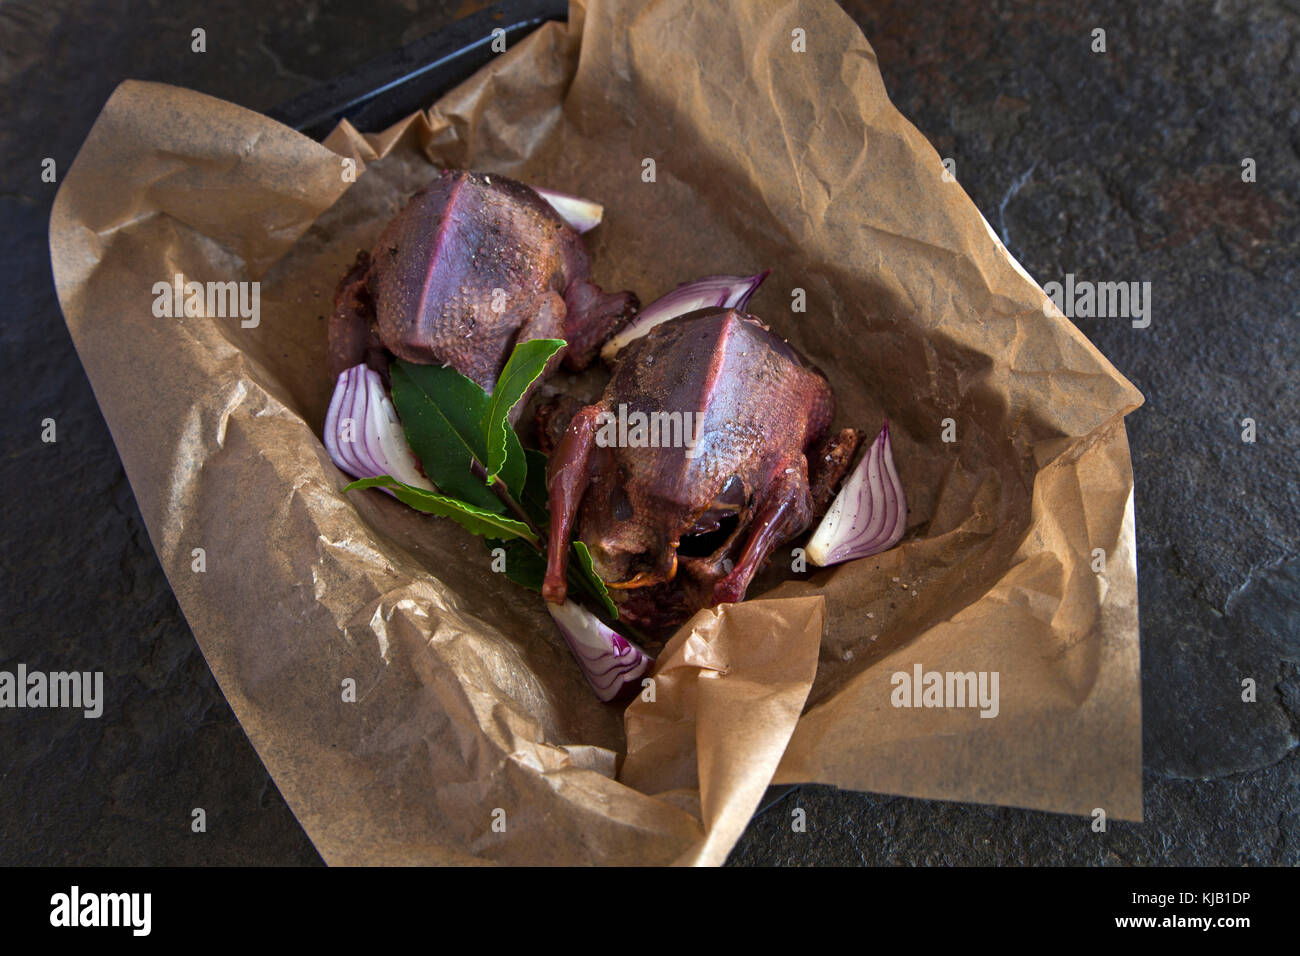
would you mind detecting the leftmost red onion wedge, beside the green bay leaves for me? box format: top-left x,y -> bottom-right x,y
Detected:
324,364 -> 436,494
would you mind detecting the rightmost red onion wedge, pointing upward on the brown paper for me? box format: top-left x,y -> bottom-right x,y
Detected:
803,421 -> 907,567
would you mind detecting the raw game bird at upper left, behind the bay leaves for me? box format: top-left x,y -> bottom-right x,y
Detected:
329,169 -> 637,390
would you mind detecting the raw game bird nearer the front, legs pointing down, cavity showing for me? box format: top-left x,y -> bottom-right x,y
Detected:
543,308 -> 858,632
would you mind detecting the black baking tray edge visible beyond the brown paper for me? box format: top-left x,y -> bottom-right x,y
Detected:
268,0 -> 798,817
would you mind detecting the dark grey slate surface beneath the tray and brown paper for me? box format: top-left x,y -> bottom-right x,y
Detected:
0,0 -> 1300,865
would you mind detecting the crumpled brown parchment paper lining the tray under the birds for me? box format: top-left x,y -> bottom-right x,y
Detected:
51,0 -> 1141,864
